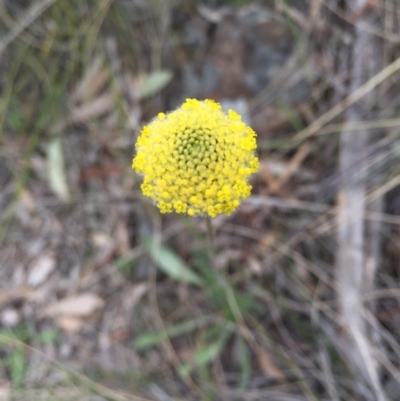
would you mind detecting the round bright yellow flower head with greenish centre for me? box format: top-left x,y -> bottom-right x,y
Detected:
132,99 -> 259,217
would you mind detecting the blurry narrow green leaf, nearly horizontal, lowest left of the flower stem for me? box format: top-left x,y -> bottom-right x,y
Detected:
133,320 -> 201,350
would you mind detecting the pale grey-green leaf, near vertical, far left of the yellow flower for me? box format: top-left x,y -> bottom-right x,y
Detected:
47,137 -> 69,201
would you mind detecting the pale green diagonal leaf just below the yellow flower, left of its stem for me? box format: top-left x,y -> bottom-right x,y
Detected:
144,241 -> 203,287
